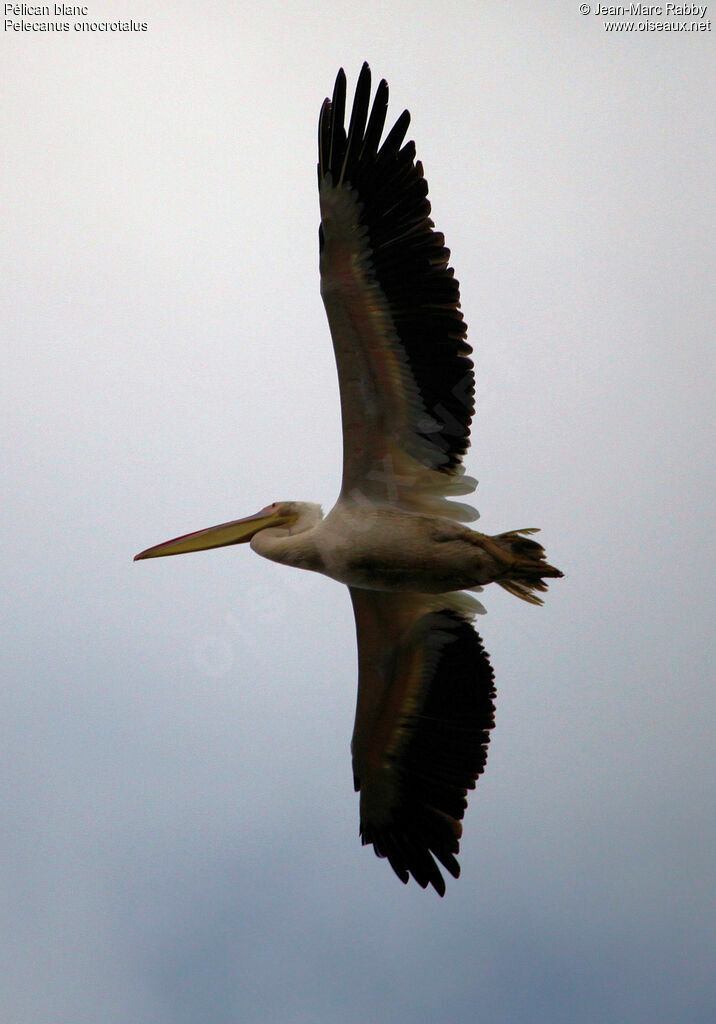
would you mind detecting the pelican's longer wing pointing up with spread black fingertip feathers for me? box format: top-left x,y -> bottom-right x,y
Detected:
319,63 -> 476,519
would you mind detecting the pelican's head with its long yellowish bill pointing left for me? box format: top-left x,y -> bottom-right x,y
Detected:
134,502 -> 323,562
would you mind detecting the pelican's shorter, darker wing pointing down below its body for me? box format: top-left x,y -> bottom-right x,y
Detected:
349,587 -> 495,896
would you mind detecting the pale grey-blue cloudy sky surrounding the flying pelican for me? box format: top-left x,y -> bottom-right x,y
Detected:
0,6 -> 716,1024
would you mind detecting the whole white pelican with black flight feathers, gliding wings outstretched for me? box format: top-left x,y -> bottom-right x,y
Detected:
136,63 -> 562,896
